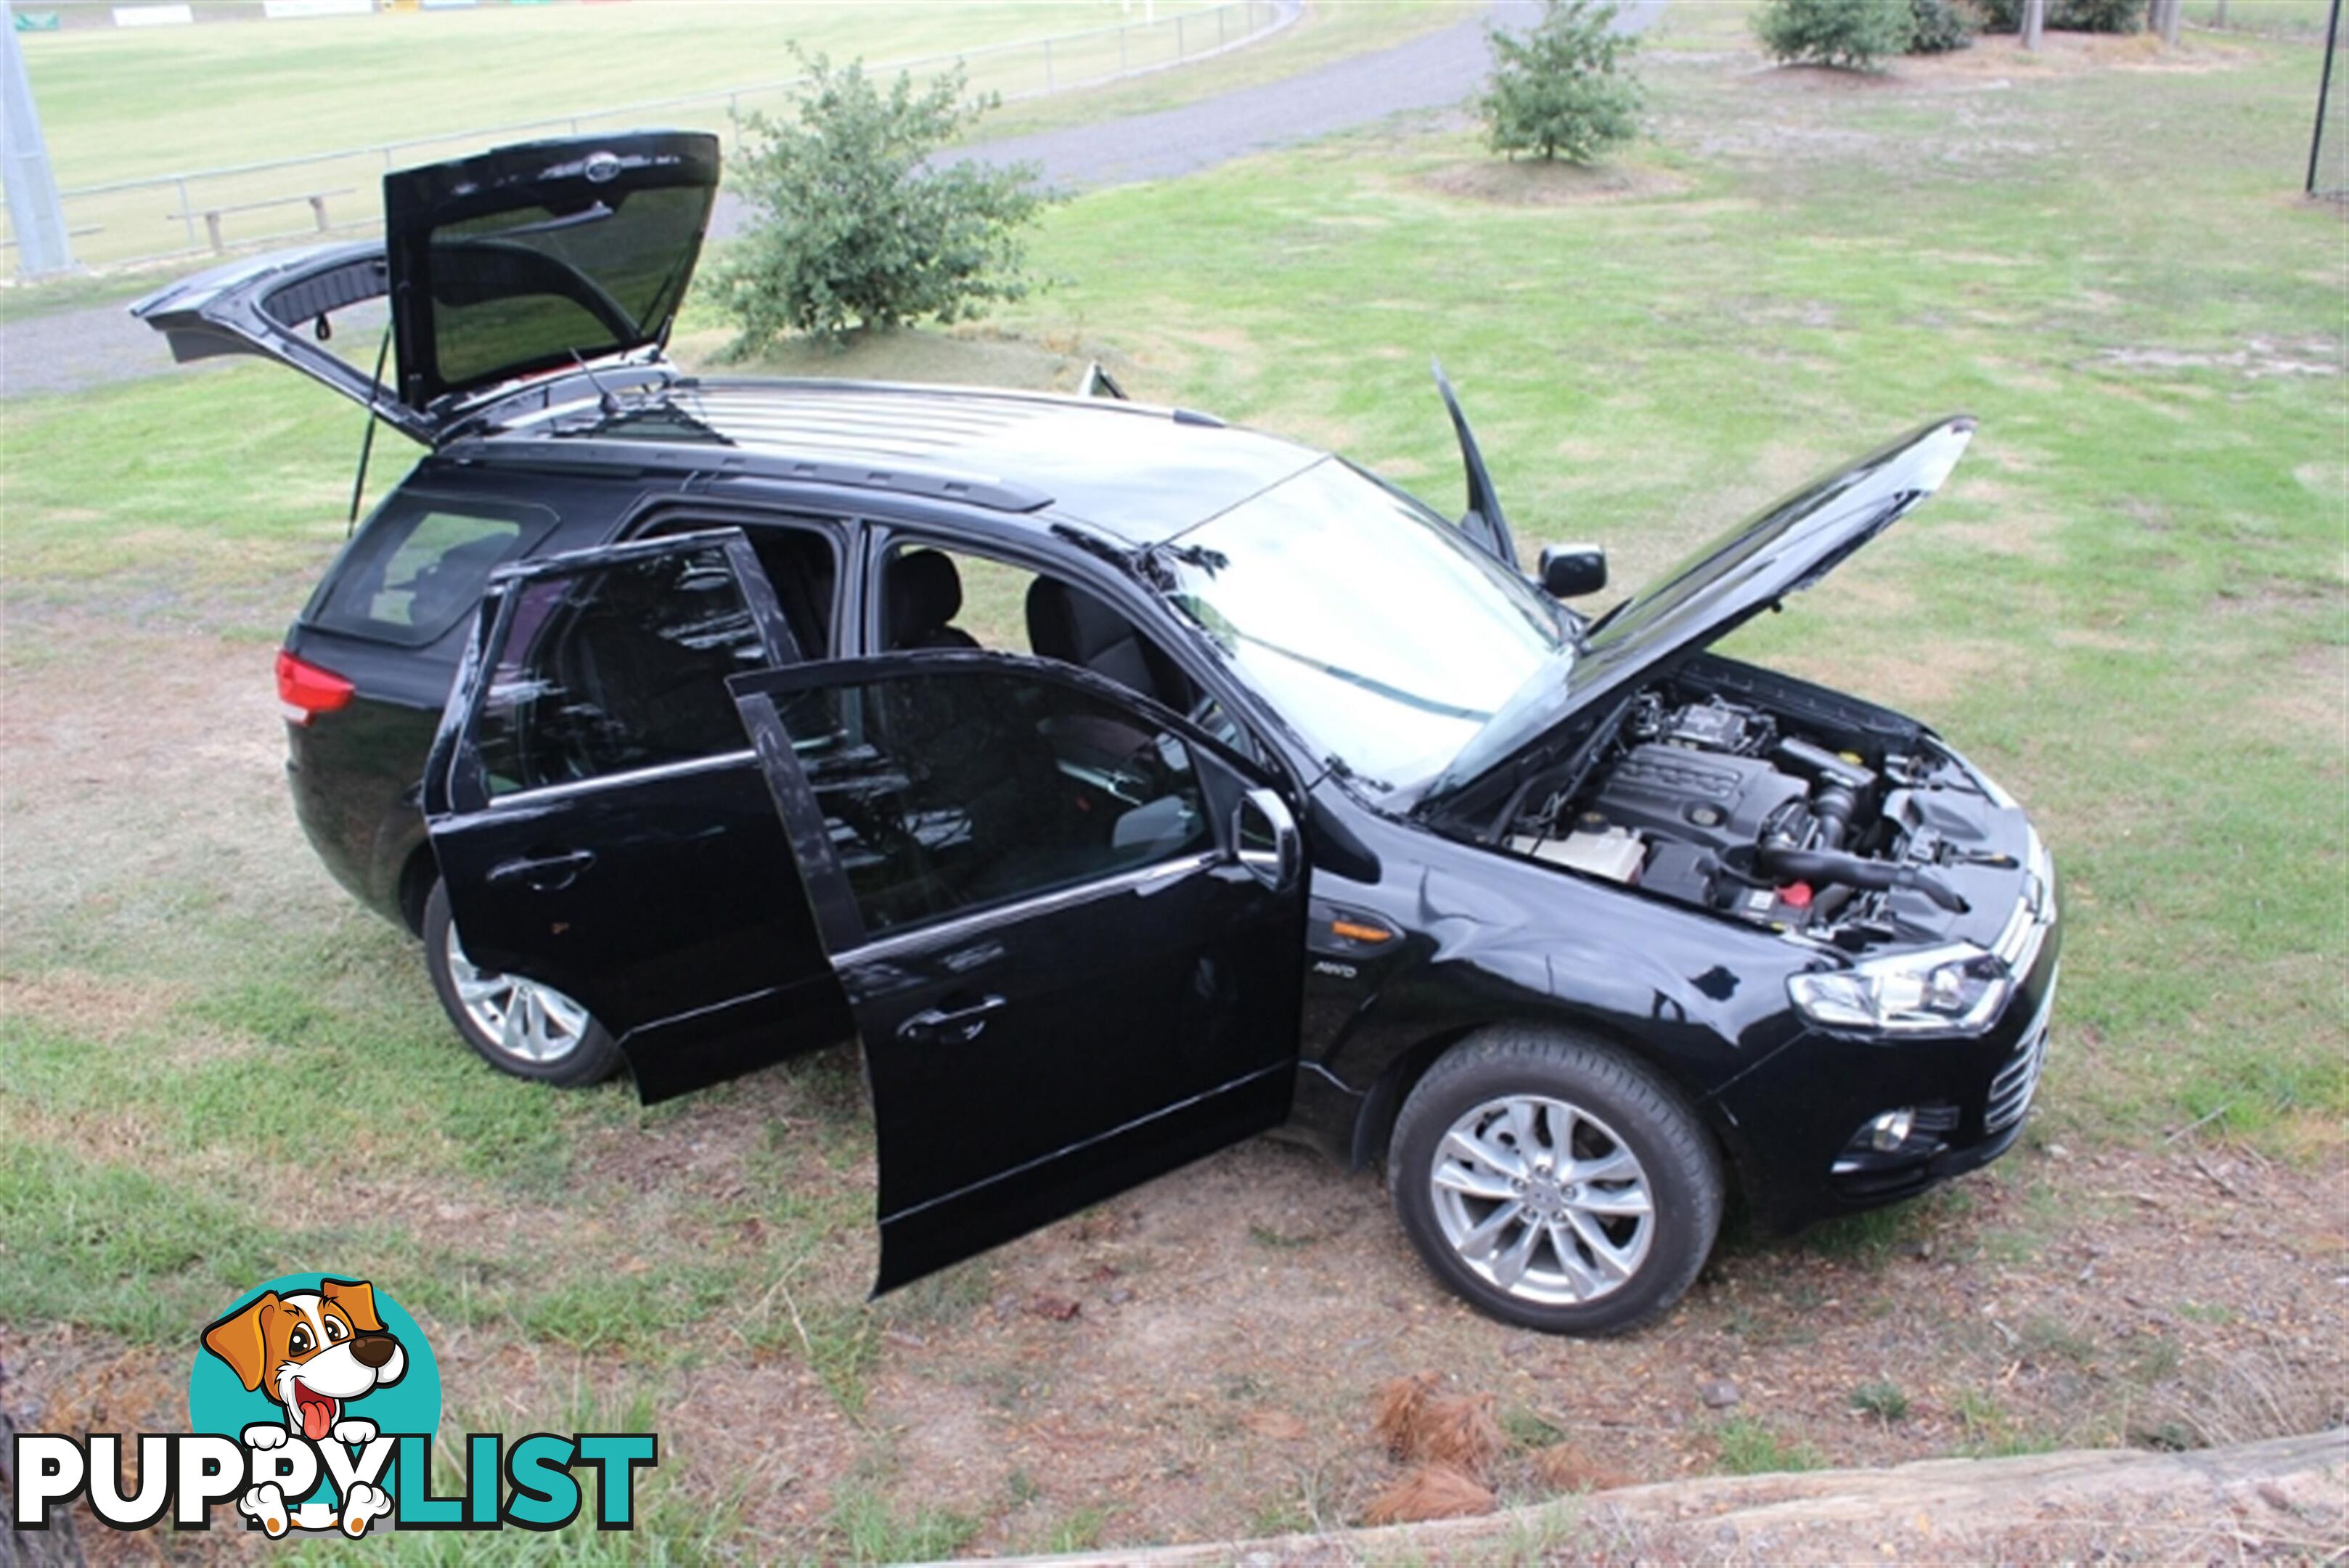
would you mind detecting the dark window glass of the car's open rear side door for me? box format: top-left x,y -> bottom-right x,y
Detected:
475,545 -> 768,795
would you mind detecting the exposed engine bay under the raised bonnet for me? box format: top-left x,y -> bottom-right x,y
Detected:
1503,670 -> 2020,950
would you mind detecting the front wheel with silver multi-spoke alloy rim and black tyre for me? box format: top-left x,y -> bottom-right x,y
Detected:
1386,1027 -> 1722,1335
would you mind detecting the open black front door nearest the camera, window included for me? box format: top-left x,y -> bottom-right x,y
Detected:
733,653 -> 1304,1291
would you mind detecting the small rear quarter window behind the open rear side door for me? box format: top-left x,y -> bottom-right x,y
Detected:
306,494 -> 555,649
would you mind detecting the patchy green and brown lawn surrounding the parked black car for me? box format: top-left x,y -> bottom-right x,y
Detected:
0,7 -> 2349,1559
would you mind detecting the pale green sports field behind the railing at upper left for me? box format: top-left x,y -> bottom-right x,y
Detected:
4,0 -> 1230,266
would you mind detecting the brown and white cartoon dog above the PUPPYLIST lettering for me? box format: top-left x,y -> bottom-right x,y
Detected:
205,1279 -> 409,1538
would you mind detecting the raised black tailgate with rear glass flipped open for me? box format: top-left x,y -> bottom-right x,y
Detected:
131,131 -> 719,444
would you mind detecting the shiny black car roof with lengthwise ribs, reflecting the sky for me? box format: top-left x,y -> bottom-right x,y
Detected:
444,376 -> 1325,545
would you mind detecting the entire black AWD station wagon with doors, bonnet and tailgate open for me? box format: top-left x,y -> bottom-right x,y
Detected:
134,131 -> 2058,1333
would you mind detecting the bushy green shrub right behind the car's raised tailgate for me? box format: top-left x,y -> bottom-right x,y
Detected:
714,45 -> 1043,353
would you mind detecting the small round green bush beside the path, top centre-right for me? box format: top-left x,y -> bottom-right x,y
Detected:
1477,0 -> 1642,165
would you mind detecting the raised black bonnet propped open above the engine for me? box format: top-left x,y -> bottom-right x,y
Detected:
1421,414 -> 1973,804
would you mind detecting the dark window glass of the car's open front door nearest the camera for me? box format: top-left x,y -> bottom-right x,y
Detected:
777,670 -> 1214,936
